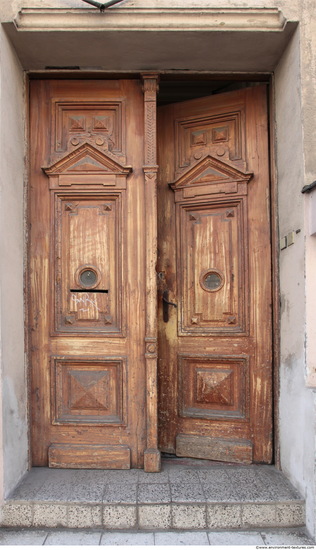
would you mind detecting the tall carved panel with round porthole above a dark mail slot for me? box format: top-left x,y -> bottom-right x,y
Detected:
54,192 -> 125,335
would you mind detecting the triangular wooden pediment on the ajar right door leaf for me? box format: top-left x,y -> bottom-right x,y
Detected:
170,155 -> 253,191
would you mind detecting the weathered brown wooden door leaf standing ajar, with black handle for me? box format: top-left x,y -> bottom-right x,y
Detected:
158,86 -> 272,463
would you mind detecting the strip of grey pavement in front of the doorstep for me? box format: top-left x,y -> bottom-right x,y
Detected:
0,528 -> 314,547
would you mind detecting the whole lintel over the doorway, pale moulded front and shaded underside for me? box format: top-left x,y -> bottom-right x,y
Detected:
3,8 -> 297,73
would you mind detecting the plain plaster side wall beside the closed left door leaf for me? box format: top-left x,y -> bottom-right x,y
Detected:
0,29 -> 28,496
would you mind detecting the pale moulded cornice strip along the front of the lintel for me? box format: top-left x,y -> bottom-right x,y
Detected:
14,8 -> 286,32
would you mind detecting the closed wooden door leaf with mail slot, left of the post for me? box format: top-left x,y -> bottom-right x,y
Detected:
29,80 -> 146,468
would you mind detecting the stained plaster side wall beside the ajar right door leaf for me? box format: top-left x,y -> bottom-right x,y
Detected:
275,31 -> 315,531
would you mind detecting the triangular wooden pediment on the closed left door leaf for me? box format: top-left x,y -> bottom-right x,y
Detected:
43,143 -> 132,176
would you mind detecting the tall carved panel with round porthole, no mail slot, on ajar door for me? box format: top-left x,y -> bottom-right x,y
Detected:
177,199 -> 248,334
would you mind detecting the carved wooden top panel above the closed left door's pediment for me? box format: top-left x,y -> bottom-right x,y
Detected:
52,99 -> 126,162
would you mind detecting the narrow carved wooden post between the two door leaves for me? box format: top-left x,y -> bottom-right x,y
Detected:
142,74 -> 161,472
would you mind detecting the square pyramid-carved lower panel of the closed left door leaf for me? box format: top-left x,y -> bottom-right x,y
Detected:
51,357 -> 126,424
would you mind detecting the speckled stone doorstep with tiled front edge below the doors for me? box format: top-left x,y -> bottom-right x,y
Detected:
1,459 -> 305,531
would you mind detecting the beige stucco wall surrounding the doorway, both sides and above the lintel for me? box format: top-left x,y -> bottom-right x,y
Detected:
0,0 -> 316,533
